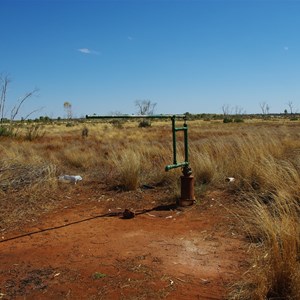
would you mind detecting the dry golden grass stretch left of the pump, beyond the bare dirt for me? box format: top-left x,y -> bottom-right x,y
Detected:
0,122 -> 177,230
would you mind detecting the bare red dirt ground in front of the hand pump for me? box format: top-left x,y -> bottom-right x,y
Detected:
0,185 -> 247,299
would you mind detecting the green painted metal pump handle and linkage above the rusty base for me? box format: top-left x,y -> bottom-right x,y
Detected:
86,115 -> 191,175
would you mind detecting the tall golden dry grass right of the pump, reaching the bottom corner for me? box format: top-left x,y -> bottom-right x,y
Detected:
188,123 -> 300,300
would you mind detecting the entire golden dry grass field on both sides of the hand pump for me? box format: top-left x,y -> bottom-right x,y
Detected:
0,119 -> 300,300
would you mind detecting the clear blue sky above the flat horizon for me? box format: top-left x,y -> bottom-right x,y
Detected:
0,0 -> 300,117
